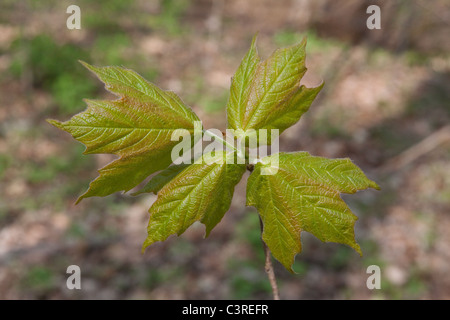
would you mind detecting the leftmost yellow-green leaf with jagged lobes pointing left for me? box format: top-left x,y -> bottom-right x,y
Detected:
48,63 -> 199,203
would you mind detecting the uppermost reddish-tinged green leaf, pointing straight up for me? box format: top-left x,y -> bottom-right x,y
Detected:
227,38 -> 323,141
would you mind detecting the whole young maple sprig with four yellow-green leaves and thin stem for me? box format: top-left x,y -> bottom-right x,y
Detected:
49,38 -> 379,298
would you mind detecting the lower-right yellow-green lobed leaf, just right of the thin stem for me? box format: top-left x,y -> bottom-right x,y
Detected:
247,152 -> 379,271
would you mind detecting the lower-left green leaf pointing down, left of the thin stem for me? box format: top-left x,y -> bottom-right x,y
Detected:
143,152 -> 246,249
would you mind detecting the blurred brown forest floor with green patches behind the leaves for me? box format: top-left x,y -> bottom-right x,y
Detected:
0,0 -> 450,299
